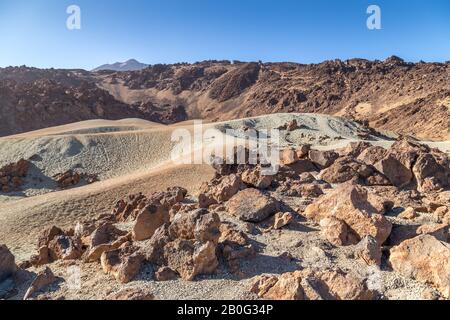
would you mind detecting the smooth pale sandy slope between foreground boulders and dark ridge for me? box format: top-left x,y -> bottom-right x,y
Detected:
0,114 -> 450,261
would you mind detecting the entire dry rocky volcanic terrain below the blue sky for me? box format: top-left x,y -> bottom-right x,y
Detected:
0,57 -> 450,300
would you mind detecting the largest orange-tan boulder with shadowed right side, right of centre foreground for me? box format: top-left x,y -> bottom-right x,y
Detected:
304,183 -> 392,244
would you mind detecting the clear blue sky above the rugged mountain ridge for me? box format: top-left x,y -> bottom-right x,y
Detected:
0,0 -> 450,69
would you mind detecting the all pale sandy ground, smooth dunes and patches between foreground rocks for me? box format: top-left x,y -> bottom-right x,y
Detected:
0,114 -> 450,299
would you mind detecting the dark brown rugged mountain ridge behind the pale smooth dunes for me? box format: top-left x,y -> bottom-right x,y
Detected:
0,56 -> 450,140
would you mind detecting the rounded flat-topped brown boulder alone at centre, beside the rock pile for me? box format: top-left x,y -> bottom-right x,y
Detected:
227,188 -> 278,222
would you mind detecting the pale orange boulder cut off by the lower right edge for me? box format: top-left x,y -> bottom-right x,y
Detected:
389,235 -> 450,299
